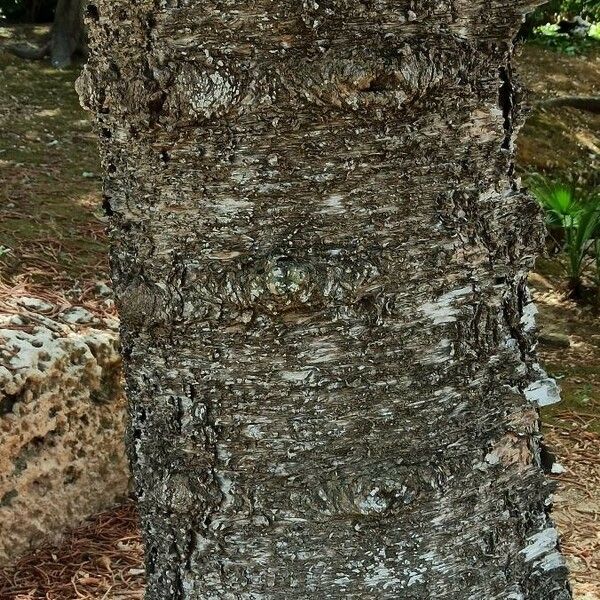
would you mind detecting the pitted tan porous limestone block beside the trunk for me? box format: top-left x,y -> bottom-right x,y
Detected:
0,299 -> 129,563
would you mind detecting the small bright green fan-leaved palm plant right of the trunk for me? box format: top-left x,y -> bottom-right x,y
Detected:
530,176 -> 600,296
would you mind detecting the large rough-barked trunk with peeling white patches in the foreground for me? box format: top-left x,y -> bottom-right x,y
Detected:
78,0 -> 571,600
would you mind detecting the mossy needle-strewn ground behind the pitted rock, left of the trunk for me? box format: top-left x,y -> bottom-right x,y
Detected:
0,28 -> 108,310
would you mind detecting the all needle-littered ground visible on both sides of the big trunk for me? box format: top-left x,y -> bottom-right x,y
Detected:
0,29 -> 600,600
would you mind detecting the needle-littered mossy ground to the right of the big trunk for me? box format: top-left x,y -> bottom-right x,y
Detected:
517,45 -> 600,600
